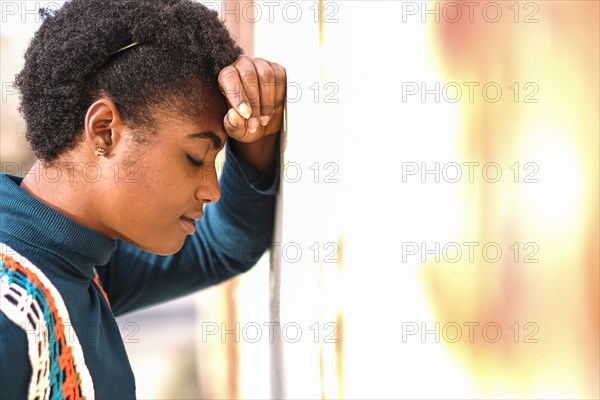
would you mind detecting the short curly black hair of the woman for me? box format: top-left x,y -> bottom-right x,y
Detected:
15,0 -> 242,163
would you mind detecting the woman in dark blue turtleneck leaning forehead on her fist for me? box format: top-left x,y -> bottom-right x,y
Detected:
0,0 -> 286,399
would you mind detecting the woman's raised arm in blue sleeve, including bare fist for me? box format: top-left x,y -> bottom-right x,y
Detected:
98,56 -> 287,314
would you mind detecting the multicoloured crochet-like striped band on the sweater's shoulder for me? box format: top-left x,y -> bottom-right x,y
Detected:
0,244 -> 94,399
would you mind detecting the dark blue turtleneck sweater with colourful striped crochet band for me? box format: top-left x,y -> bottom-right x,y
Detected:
0,141 -> 279,399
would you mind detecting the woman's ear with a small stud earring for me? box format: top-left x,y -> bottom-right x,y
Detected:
83,98 -> 125,155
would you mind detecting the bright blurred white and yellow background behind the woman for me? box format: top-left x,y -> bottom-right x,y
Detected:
0,0 -> 600,399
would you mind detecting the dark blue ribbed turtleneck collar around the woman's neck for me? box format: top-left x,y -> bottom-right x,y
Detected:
0,174 -> 117,278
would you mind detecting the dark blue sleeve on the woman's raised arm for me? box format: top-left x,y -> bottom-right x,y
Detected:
98,136 -> 279,315
